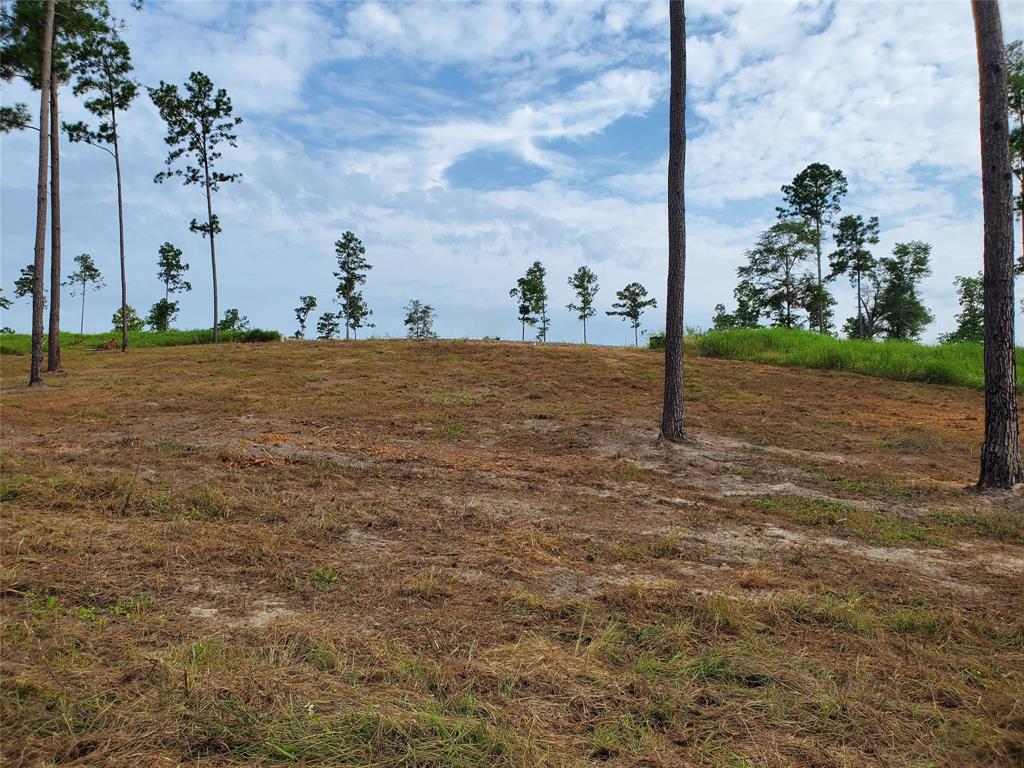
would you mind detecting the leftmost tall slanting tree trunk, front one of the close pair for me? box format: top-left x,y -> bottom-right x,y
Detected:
29,0 -> 54,387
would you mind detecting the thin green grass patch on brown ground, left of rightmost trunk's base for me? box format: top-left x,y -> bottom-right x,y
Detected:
750,495 -> 944,545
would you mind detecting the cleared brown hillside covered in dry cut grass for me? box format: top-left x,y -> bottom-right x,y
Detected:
0,341 -> 1024,768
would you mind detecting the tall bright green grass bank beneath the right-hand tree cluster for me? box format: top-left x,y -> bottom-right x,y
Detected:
694,328 -> 1024,392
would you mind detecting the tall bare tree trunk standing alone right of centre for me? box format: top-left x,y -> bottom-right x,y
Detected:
662,0 -> 686,442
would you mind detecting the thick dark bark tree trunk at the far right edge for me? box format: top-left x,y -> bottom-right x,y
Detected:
971,0 -> 1024,488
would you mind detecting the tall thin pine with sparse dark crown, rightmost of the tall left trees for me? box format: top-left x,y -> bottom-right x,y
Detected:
148,72 -> 242,342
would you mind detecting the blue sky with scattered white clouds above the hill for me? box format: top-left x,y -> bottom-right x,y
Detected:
0,0 -> 1024,344
